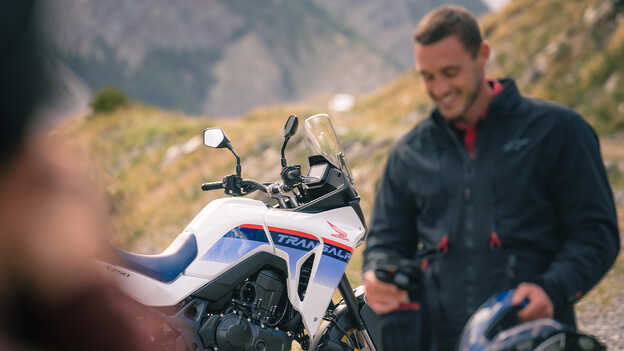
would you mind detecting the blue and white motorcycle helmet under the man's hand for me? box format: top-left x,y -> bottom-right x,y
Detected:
457,290 -> 606,351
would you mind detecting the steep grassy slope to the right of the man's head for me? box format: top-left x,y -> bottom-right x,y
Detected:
482,0 -> 624,135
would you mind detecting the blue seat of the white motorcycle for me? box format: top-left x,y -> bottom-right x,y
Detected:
114,234 -> 197,283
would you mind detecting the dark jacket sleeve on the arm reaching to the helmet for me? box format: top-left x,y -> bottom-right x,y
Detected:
535,114 -> 620,311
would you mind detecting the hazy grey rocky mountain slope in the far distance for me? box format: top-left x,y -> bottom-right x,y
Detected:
49,0 -> 486,115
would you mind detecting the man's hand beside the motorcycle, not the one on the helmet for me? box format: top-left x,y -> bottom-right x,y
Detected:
362,271 -> 409,314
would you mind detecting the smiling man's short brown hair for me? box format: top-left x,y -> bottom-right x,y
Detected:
414,5 -> 483,56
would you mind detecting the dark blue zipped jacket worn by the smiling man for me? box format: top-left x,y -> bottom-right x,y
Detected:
364,80 -> 620,345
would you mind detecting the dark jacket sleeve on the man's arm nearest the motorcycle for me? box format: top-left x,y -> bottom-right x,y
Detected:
362,147 -> 418,272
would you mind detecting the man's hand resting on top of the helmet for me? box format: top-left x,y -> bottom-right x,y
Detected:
511,283 -> 555,322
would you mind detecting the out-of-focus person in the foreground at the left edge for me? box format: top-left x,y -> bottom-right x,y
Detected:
0,0 -> 163,350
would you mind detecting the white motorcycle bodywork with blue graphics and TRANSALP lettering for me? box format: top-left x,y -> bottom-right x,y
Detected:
102,198 -> 365,336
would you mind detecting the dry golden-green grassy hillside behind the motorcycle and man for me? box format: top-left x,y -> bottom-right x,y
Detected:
61,0 -> 624,290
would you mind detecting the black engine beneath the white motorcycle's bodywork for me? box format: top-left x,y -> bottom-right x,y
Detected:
199,269 -> 292,351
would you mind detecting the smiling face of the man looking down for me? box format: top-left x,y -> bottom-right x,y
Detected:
414,35 -> 489,120
